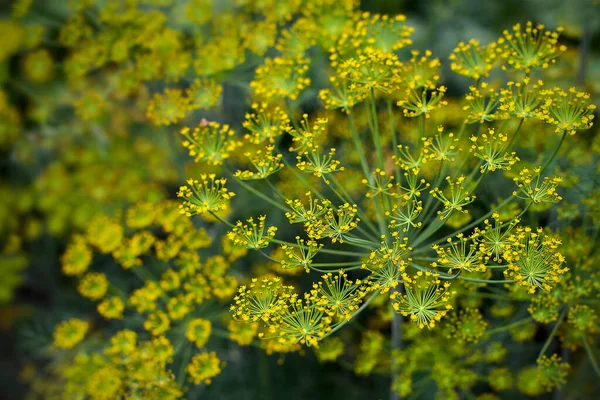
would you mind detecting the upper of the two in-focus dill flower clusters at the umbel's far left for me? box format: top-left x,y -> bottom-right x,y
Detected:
181,120 -> 242,165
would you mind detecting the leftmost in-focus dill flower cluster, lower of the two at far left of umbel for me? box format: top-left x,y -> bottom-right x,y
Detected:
177,174 -> 235,217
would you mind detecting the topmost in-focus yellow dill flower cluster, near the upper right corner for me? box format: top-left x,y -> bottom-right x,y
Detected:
498,21 -> 567,73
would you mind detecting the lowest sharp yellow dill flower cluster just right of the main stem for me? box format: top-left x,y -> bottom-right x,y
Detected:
390,271 -> 454,329
